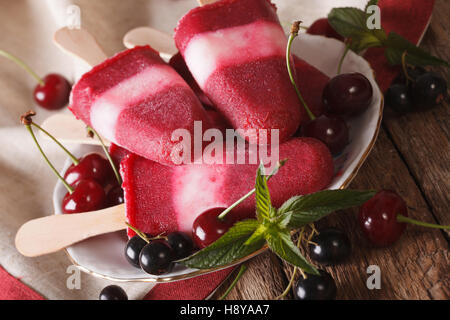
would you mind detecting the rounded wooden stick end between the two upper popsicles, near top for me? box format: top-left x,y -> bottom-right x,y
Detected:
123,27 -> 178,60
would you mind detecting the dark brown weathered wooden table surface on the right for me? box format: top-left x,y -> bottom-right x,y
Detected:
213,0 -> 450,300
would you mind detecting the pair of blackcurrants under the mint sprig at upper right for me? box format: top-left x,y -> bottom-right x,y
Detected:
385,66 -> 447,113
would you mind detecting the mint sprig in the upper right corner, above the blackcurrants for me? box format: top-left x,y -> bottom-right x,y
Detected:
328,0 -> 449,67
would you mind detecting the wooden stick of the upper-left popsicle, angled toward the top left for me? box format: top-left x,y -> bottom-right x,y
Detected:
53,27 -> 107,66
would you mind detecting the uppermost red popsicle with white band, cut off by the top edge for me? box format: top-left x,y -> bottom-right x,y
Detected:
174,0 -> 306,142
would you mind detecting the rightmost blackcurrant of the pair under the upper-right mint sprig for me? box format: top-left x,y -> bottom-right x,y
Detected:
411,72 -> 447,109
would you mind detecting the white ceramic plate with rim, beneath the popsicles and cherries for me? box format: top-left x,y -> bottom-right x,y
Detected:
53,34 -> 383,282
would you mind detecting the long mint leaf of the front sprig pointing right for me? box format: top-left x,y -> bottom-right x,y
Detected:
278,190 -> 376,229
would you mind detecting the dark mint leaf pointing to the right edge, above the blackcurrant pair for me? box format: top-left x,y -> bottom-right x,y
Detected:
384,32 -> 449,67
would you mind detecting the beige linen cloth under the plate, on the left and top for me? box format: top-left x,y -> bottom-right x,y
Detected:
0,0 -> 365,299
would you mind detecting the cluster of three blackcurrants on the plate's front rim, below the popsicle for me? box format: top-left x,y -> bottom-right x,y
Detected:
125,232 -> 194,275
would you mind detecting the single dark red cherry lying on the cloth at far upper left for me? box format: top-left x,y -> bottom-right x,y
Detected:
33,73 -> 71,110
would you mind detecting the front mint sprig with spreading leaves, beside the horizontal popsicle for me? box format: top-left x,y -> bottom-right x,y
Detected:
179,164 -> 375,274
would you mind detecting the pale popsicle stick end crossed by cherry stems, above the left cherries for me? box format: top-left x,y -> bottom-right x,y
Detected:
40,114 -> 111,146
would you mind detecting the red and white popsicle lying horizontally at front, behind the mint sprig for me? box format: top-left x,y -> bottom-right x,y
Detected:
121,138 -> 333,235
